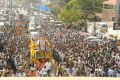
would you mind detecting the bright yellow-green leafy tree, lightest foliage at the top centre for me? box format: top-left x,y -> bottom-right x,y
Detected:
59,0 -> 82,24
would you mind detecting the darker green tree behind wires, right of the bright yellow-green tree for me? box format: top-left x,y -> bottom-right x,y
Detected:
77,0 -> 104,31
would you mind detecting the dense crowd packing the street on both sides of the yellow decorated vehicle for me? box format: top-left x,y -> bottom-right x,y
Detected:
0,24 -> 120,77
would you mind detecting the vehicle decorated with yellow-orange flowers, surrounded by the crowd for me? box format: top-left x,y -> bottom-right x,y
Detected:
30,32 -> 52,64
